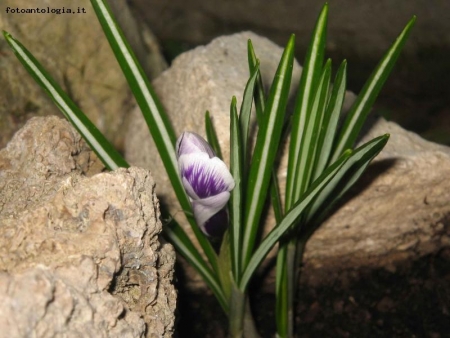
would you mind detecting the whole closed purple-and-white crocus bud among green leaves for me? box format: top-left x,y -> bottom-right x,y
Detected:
176,132 -> 234,237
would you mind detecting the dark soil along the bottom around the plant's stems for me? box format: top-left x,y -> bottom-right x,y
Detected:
177,249 -> 450,338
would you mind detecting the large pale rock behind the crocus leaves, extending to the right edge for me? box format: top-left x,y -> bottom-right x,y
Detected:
127,33 -> 450,290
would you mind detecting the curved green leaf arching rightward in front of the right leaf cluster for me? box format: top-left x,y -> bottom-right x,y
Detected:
239,150 -> 352,290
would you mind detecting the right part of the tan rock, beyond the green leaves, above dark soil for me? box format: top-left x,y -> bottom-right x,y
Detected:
305,118 -> 450,282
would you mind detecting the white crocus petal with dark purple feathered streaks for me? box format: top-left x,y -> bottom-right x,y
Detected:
178,153 -> 234,199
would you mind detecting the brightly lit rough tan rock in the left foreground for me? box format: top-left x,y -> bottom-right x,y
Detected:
0,117 -> 176,337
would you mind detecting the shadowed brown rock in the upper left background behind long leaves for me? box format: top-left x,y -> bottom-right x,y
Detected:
0,0 -> 165,148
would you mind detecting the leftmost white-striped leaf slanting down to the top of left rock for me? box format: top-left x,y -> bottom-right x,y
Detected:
3,31 -> 129,170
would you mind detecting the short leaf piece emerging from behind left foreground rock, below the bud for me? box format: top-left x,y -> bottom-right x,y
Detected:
164,223 -> 228,313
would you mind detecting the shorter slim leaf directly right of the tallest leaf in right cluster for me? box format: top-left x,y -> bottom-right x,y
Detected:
293,60 -> 331,200
